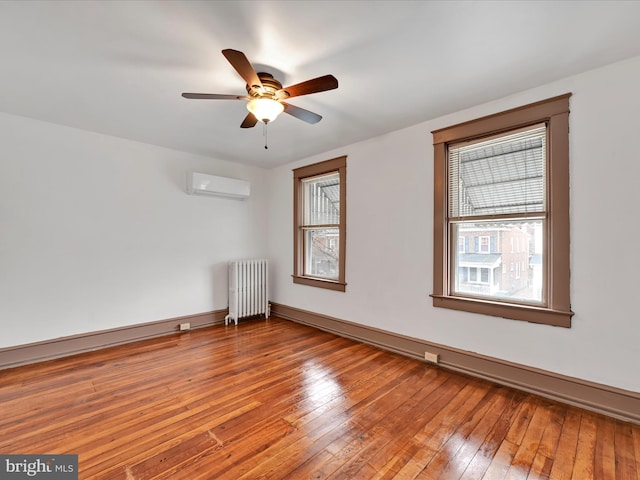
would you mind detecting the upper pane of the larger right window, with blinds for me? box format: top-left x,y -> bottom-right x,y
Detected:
449,126 -> 546,217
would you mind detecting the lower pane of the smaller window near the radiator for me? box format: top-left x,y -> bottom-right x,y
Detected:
304,228 -> 340,280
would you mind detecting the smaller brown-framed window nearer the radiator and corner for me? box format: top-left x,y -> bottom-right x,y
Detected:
293,156 -> 347,292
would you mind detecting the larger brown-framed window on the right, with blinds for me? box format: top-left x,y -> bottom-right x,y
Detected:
431,94 -> 573,327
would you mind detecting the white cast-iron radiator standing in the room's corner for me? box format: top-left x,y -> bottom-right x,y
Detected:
224,259 -> 269,325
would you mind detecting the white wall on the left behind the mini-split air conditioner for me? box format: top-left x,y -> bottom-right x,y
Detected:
0,114 -> 267,348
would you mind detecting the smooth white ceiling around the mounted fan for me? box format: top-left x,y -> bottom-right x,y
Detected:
0,0 -> 640,168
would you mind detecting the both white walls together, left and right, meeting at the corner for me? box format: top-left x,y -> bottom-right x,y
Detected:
0,57 -> 640,391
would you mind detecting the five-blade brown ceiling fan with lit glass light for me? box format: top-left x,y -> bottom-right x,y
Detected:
182,48 -> 338,128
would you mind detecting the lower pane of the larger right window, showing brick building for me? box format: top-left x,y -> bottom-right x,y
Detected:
451,220 -> 544,304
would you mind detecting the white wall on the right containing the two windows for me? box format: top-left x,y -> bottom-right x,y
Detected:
269,57 -> 640,391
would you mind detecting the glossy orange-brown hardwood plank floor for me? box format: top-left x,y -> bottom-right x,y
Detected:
0,318 -> 640,480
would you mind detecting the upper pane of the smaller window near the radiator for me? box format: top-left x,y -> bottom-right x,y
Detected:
302,172 -> 340,225
